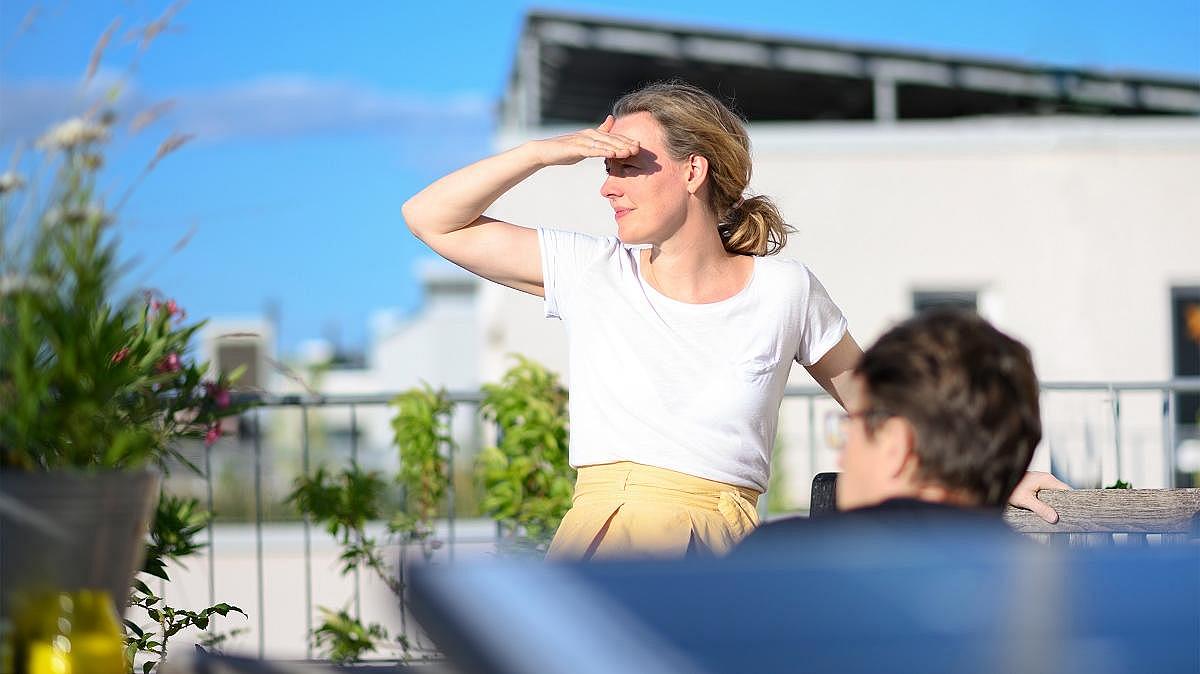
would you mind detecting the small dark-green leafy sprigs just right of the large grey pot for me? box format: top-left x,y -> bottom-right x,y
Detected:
125,494 -> 246,674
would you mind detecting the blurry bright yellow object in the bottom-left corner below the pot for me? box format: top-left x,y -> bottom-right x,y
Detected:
24,590 -> 127,674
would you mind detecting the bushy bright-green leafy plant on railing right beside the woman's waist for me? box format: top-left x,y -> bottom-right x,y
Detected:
478,356 -> 575,550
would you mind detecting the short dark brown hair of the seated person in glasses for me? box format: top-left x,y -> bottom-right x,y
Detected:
854,309 -> 1042,507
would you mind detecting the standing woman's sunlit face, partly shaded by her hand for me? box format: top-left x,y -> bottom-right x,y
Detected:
600,113 -> 690,245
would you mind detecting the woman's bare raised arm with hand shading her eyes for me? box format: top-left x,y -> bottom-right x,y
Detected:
402,116 -> 640,296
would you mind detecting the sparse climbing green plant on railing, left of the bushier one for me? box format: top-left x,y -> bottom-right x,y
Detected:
288,385 -> 454,662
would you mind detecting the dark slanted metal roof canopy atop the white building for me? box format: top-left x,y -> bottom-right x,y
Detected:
502,11 -> 1200,127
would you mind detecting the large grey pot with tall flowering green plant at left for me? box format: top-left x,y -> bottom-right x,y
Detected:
0,106 -> 242,627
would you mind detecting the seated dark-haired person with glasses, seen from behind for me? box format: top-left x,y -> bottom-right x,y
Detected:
739,309 -> 1042,554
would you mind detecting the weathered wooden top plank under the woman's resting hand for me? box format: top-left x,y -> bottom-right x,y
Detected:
1004,489 -> 1200,534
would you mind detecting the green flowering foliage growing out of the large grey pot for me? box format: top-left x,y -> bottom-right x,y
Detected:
0,81 -> 245,470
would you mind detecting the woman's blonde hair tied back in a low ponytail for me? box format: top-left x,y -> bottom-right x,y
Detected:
612,82 -> 792,255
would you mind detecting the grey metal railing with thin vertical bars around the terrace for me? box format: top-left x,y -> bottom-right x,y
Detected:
184,377 -> 1200,658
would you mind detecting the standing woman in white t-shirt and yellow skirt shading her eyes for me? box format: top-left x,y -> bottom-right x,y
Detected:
403,83 -> 1061,559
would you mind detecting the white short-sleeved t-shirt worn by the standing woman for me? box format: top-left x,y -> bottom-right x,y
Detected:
538,229 -> 846,492
